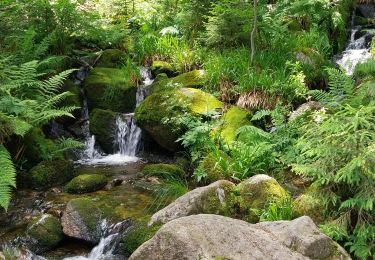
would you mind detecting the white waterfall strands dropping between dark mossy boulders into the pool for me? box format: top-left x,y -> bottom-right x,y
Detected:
80,67 -> 153,164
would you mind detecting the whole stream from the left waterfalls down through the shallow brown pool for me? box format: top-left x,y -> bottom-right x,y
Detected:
0,68 -> 159,260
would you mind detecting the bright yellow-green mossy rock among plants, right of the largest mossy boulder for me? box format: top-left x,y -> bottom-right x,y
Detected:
220,107 -> 251,144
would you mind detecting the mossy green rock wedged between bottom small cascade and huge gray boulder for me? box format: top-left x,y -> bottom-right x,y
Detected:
122,221 -> 161,256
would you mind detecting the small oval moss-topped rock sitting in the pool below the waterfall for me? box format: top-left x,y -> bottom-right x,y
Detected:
65,174 -> 107,193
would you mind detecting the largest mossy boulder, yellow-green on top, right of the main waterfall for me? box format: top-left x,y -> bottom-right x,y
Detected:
135,88 -> 223,151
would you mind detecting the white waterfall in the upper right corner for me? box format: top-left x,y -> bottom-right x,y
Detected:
335,12 -> 372,75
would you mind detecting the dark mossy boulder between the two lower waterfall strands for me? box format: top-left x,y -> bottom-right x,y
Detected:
90,109 -> 116,153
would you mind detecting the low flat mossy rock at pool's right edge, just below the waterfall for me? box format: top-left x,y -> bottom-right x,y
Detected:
142,164 -> 185,179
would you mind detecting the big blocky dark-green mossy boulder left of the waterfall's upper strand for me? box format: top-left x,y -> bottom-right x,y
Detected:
84,68 -> 137,113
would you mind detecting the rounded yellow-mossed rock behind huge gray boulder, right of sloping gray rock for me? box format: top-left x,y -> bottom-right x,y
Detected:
236,174 -> 290,223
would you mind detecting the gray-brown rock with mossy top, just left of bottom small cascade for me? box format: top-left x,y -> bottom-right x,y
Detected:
61,198 -> 104,243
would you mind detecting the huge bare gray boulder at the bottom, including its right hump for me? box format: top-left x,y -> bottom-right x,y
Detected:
129,215 -> 350,260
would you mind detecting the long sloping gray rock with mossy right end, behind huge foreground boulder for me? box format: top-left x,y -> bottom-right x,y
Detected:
149,180 -> 235,226
